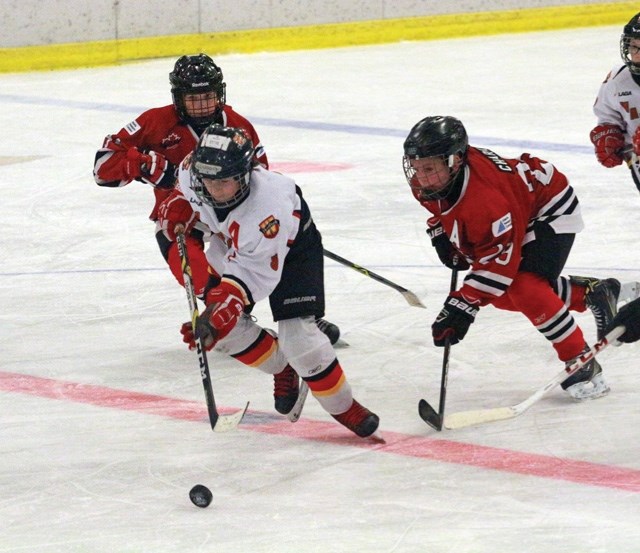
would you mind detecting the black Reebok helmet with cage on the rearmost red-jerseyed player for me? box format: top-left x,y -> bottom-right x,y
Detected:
169,54 -> 227,129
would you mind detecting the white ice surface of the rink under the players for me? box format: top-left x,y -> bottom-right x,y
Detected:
0,27 -> 640,553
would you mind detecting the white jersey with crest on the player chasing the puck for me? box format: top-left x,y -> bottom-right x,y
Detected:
178,163 -> 302,304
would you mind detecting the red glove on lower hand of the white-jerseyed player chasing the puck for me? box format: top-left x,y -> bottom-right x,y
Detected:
196,283 -> 244,350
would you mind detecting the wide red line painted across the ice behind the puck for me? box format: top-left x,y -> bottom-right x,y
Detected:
0,371 -> 640,493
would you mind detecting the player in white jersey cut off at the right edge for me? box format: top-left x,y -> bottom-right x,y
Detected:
590,13 -> 640,190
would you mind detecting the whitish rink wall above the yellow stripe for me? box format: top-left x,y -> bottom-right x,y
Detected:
0,0 -> 615,48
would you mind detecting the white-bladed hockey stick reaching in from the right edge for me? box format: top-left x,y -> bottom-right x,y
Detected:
444,326 -> 625,430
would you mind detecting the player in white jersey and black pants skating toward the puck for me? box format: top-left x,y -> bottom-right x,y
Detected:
161,125 -> 379,437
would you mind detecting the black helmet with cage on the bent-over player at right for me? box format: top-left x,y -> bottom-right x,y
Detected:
402,115 -> 469,201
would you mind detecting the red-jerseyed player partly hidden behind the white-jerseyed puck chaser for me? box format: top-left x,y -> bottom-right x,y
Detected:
93,54 -> 269,294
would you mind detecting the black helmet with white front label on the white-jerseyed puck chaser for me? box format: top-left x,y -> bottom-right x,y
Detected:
191,124 -> 255,208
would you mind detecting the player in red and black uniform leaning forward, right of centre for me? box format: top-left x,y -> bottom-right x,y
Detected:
403,116 -> 620,400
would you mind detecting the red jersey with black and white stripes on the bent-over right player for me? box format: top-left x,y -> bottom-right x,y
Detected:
421,147 -> 583,305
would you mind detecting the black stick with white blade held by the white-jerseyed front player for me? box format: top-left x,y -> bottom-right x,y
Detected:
175,225 -> 249,432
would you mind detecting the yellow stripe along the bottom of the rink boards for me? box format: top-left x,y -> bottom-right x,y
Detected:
0,2 -> 640,73
